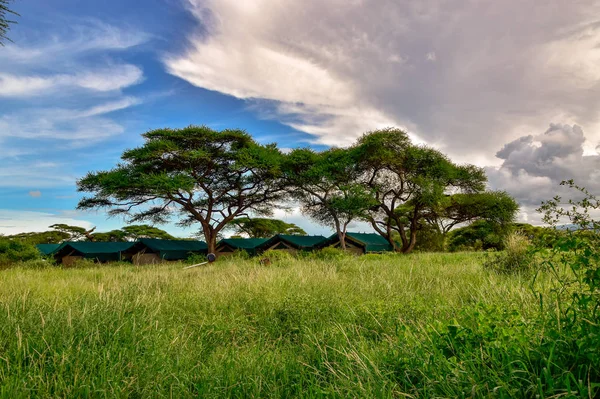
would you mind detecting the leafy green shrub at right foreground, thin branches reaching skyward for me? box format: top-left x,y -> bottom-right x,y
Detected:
538,180 -> 600,384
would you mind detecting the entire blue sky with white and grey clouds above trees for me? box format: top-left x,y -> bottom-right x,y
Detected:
0,0 -> 600,236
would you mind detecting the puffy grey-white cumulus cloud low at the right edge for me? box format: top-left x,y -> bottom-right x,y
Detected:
487,124 -> 600,221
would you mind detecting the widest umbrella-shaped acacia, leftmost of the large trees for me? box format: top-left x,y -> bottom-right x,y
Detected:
77,126 -> 286,252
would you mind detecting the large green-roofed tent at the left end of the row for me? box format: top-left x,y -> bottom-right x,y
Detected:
52,241 -> 136,266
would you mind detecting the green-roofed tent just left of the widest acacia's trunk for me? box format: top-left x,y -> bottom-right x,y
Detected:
131,238 -> 208,265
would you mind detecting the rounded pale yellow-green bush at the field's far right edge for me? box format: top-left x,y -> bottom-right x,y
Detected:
484,232 -> 533,274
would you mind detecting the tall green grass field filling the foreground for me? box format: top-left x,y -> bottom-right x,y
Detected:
0,253 -> 591,398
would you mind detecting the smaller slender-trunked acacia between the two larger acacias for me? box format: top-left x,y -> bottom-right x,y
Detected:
284,148 -> 374,249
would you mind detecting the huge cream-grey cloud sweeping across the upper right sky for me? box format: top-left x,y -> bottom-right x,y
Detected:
165,0 -> 600,165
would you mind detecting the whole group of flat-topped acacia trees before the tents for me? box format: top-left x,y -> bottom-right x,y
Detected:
78,126 -> 518,253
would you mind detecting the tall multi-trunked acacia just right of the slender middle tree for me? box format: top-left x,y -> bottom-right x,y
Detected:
353,128 -> 486,253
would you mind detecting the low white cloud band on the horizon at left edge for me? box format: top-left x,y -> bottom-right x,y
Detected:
0,209 -> 93,235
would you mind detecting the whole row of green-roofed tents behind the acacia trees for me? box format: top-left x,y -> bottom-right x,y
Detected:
37,233 -> 393,266
